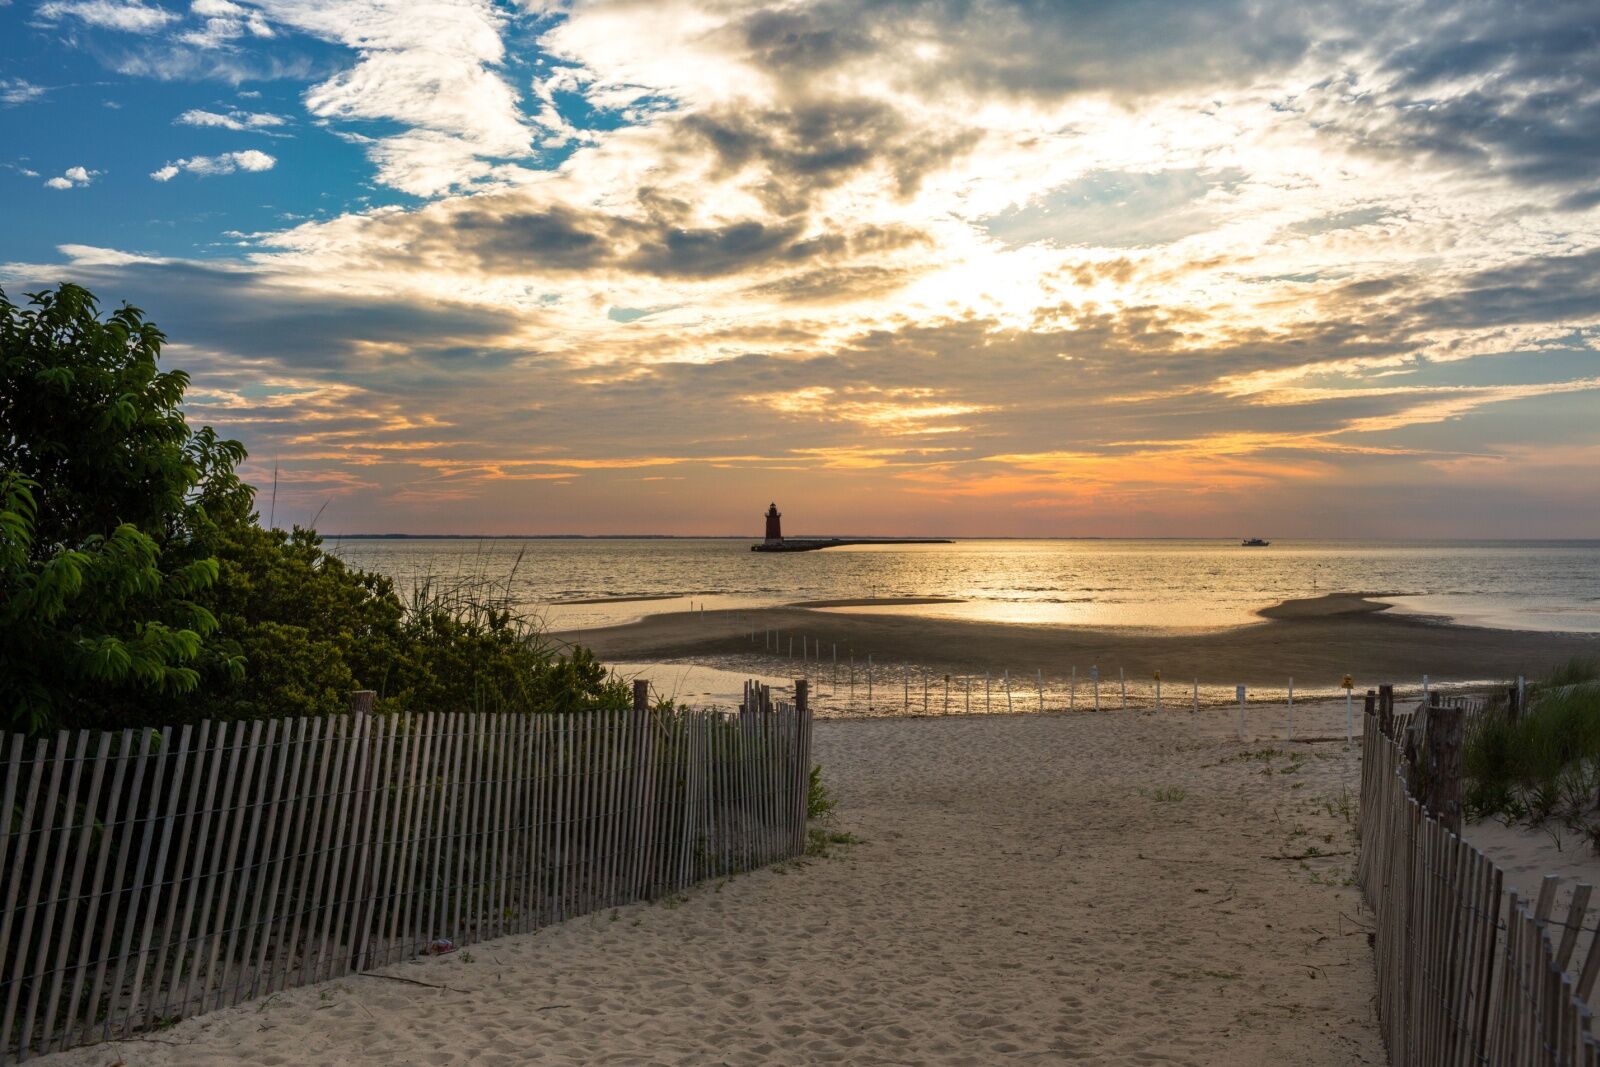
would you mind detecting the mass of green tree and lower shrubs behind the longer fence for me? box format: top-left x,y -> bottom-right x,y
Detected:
0,285 -> 629,733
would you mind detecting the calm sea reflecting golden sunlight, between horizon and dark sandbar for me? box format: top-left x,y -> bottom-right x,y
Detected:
328,539 -> 1600,632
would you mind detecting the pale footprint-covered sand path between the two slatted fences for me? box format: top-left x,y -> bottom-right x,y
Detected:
43,705 -> 1384,1067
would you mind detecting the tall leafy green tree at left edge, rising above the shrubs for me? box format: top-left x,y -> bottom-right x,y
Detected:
0,285 -> 250,731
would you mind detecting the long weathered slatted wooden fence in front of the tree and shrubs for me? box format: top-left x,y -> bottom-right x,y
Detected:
0,683 -> 811,1062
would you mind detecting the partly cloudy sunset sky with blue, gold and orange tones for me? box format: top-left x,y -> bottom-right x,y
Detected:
0,0 -> 1600,537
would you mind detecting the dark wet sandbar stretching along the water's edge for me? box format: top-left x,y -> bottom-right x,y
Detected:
555,593 -> 1600,686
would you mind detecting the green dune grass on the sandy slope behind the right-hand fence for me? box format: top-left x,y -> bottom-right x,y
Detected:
1461,659 -> 1600,841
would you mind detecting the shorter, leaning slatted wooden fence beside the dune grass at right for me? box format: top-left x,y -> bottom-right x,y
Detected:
1357,709 -> 1600,1067
